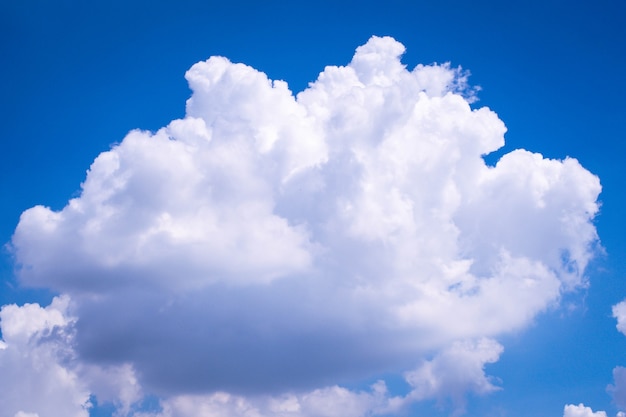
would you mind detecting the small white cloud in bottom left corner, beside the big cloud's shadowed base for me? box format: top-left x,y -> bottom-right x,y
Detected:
0,296 -> 142,417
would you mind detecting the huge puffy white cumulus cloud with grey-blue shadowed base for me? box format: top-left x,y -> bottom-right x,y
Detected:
6,37 -> 601,415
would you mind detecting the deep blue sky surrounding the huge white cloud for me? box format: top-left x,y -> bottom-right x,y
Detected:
0,0 -> 626,417
